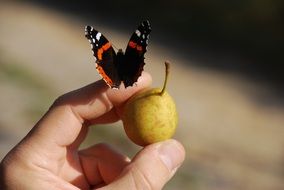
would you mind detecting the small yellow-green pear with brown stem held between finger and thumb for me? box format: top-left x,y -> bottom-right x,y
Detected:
122,62 -> 178,146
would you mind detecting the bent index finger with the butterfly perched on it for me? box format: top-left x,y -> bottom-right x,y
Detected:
28,73 -> 152,148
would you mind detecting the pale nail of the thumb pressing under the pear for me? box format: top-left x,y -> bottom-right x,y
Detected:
158,140 -> 184,171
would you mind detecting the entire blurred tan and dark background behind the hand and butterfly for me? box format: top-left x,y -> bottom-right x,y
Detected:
0,0 -> 284,190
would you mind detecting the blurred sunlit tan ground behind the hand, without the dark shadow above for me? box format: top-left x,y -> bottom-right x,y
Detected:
0,3 -> 284,190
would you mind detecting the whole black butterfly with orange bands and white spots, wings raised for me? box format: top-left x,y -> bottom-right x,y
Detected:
85,20 -> 151,88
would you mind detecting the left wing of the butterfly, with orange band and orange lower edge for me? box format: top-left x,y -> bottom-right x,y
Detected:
85,26 -> 121,88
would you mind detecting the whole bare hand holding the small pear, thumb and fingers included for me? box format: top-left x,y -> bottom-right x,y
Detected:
0,73 -> 185,190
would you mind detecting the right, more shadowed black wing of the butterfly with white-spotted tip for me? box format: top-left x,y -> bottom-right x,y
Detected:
118,20 -> 151,87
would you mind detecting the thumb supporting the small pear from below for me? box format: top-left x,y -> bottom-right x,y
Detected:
105,139 -> 185,190
